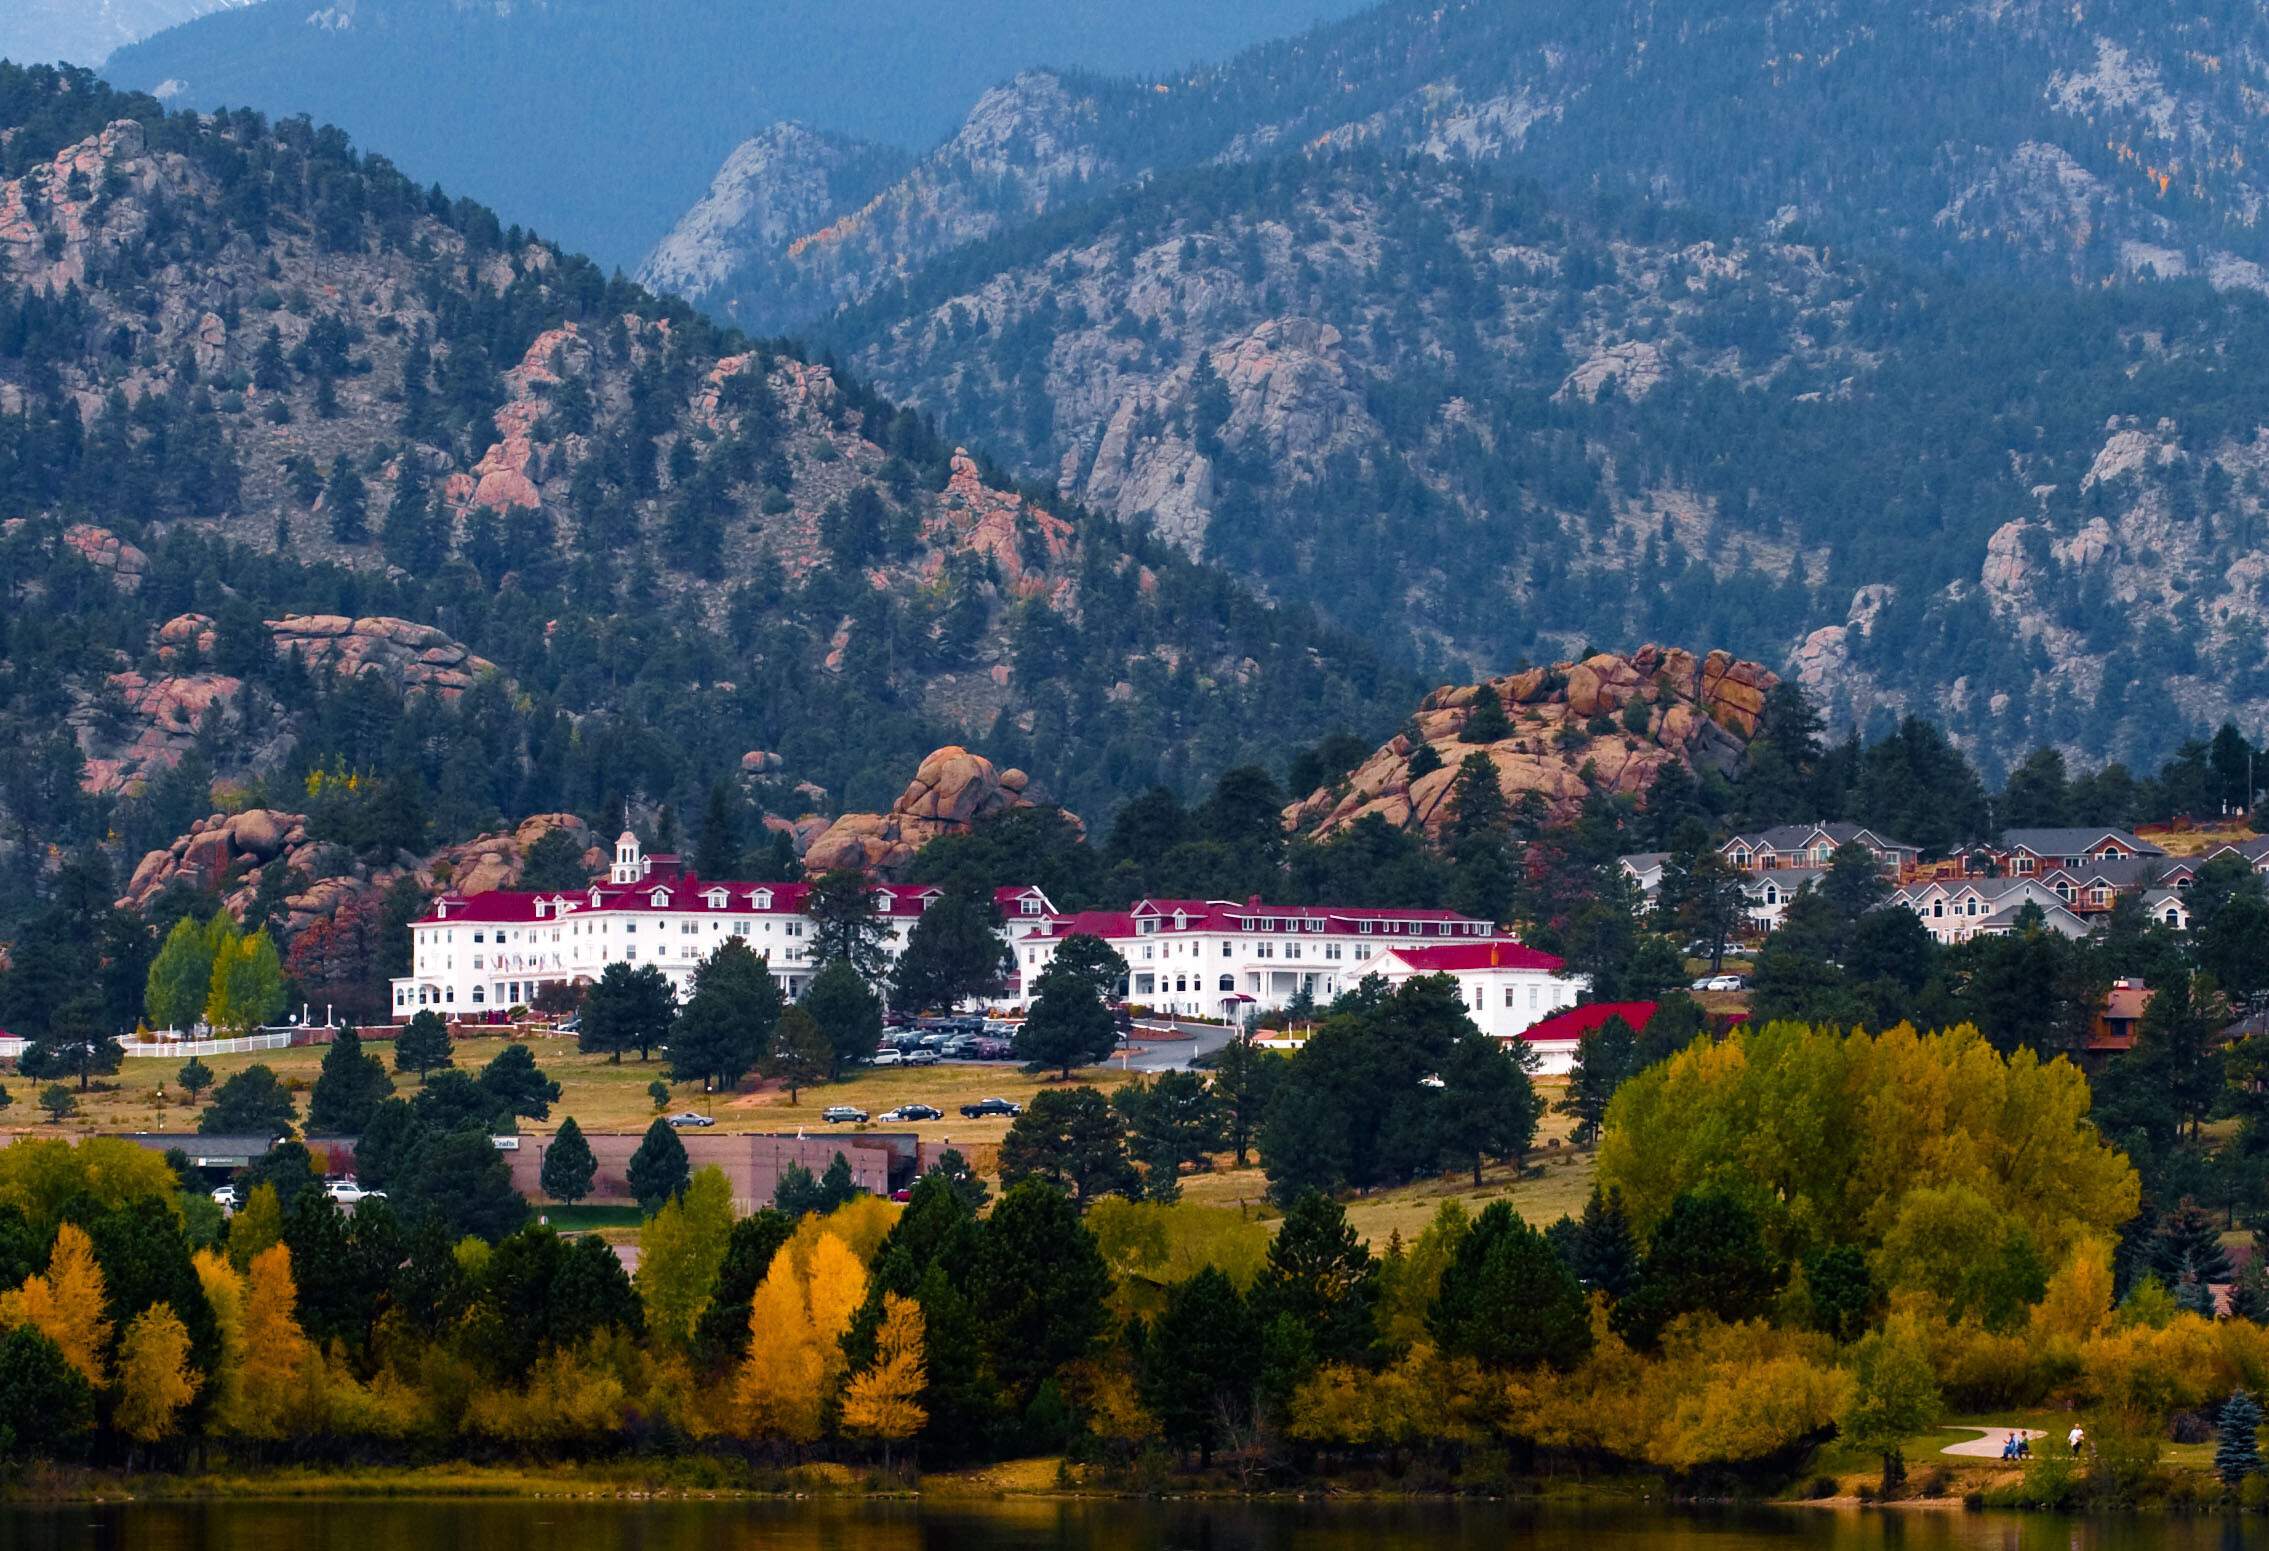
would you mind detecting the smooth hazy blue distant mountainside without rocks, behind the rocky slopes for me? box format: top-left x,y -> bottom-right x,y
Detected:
109,0 -> 1355,265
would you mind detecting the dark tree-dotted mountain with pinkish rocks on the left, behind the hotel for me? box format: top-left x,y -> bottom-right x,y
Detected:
0,70 -> 1407,907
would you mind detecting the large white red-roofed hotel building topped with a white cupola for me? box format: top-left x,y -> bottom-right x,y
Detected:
393,830 -> 1055,1023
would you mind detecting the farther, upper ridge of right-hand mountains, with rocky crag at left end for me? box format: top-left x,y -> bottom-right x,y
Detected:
658,0 -> 2269,322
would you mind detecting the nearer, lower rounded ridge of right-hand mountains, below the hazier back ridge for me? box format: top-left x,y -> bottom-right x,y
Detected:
821,152 -> 2269,775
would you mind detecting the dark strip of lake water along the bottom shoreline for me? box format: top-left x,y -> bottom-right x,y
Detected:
0,1501 -> 2269,1551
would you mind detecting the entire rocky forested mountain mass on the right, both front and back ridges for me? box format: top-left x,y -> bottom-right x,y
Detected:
626,0 -> 2269,771
